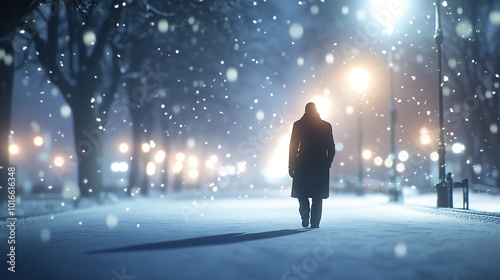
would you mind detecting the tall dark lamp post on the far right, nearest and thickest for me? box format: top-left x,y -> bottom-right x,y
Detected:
434,0 -> 451,207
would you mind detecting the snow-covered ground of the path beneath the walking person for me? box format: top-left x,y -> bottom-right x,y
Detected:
0,192 -> 500,280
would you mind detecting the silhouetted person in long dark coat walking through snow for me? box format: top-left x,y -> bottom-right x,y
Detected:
288,103 -> 335,228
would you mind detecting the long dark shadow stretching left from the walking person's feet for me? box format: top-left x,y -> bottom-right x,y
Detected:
86,229 -> 308,254
